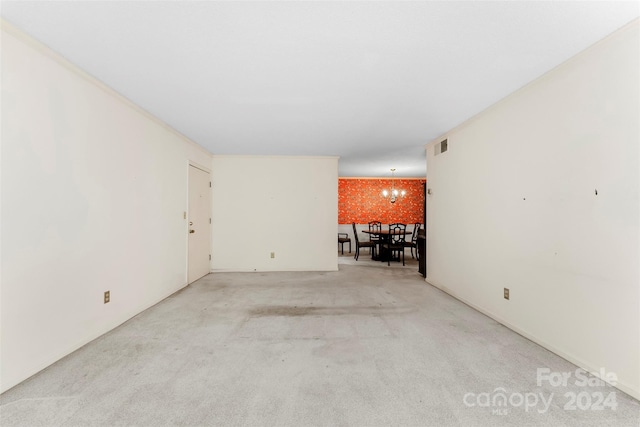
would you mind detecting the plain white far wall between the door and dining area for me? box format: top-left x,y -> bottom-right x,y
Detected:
211,156 -> 338,271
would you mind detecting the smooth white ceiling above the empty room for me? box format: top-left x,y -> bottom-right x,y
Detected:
1,1 -> 640,177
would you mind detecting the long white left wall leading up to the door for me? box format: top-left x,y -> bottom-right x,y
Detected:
0,22 -> 211,391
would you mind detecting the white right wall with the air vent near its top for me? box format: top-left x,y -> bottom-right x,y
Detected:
427,20 -> 640,398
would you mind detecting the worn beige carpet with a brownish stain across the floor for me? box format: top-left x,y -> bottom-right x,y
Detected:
0,260 -> 640,427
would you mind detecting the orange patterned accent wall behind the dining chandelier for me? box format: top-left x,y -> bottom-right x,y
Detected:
338,178 -> 426,224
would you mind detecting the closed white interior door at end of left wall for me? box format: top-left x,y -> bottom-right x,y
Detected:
187,165 -> 211,283
